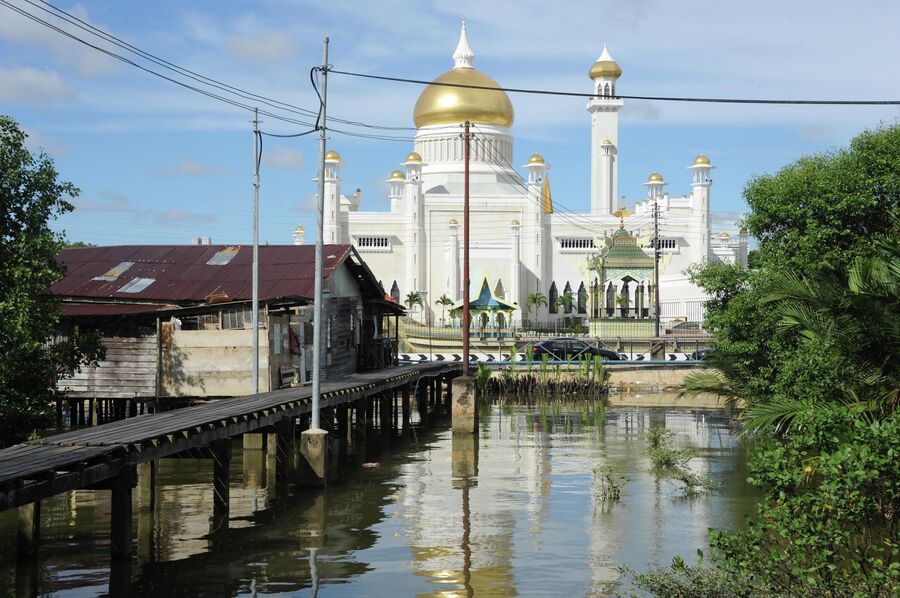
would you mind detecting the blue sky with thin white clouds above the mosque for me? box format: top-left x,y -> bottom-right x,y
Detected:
0,0 -> 900,245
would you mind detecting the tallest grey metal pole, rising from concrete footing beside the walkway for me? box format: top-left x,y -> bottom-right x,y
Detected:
309,37 -> 328,430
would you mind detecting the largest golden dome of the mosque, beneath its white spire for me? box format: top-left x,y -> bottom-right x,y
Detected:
413,67 -> 516,128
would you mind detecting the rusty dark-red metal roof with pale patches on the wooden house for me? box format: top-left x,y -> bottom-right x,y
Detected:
51,245 -> 351,304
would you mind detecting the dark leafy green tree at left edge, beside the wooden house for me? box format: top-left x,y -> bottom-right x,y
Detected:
0,116 -> 103,446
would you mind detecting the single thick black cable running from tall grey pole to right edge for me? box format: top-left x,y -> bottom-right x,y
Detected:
329,69 -> 900,106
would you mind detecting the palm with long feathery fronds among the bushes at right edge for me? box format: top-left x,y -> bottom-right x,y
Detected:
684,239 -> 900,432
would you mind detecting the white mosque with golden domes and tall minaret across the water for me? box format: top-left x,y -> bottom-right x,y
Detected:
295,22 -> 747,324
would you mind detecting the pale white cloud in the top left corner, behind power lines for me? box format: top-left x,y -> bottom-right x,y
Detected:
0,4 -> 116,77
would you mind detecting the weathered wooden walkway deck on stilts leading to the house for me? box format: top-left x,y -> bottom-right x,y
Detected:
0,363 -> 461,511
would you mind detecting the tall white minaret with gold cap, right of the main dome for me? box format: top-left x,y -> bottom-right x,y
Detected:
587,44 -> 622,214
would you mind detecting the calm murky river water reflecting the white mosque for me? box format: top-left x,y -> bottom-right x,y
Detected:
0,403 -> 756,597
